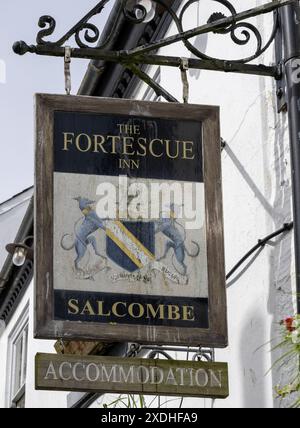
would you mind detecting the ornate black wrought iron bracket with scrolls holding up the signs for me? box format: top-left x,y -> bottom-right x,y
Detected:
13,0 -> 297,78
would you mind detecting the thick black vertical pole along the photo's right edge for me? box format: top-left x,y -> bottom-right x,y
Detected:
281,2 -> 300,313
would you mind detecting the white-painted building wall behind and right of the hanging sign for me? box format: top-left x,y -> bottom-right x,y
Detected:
131,0 -> 295,408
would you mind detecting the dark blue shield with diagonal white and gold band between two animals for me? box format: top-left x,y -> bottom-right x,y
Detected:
106,221 -> 155,272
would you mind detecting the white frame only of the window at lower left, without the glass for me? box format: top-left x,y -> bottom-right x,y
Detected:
6,303 -> 29,408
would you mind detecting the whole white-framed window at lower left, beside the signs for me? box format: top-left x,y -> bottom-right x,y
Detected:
7,307 -> 29,408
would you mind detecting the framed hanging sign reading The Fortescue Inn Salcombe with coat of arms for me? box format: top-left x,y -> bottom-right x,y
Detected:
35,95 -> 227,347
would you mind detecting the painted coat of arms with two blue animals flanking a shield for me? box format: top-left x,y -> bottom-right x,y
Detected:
61,197 -> 200,284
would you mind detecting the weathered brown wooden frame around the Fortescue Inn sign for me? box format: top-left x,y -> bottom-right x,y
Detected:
35,94 -> 227,347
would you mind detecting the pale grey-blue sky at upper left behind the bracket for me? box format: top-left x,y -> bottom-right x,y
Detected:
0,0 -> 114,203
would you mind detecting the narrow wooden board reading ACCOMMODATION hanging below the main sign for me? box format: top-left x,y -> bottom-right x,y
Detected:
35,354 -> 229,398
